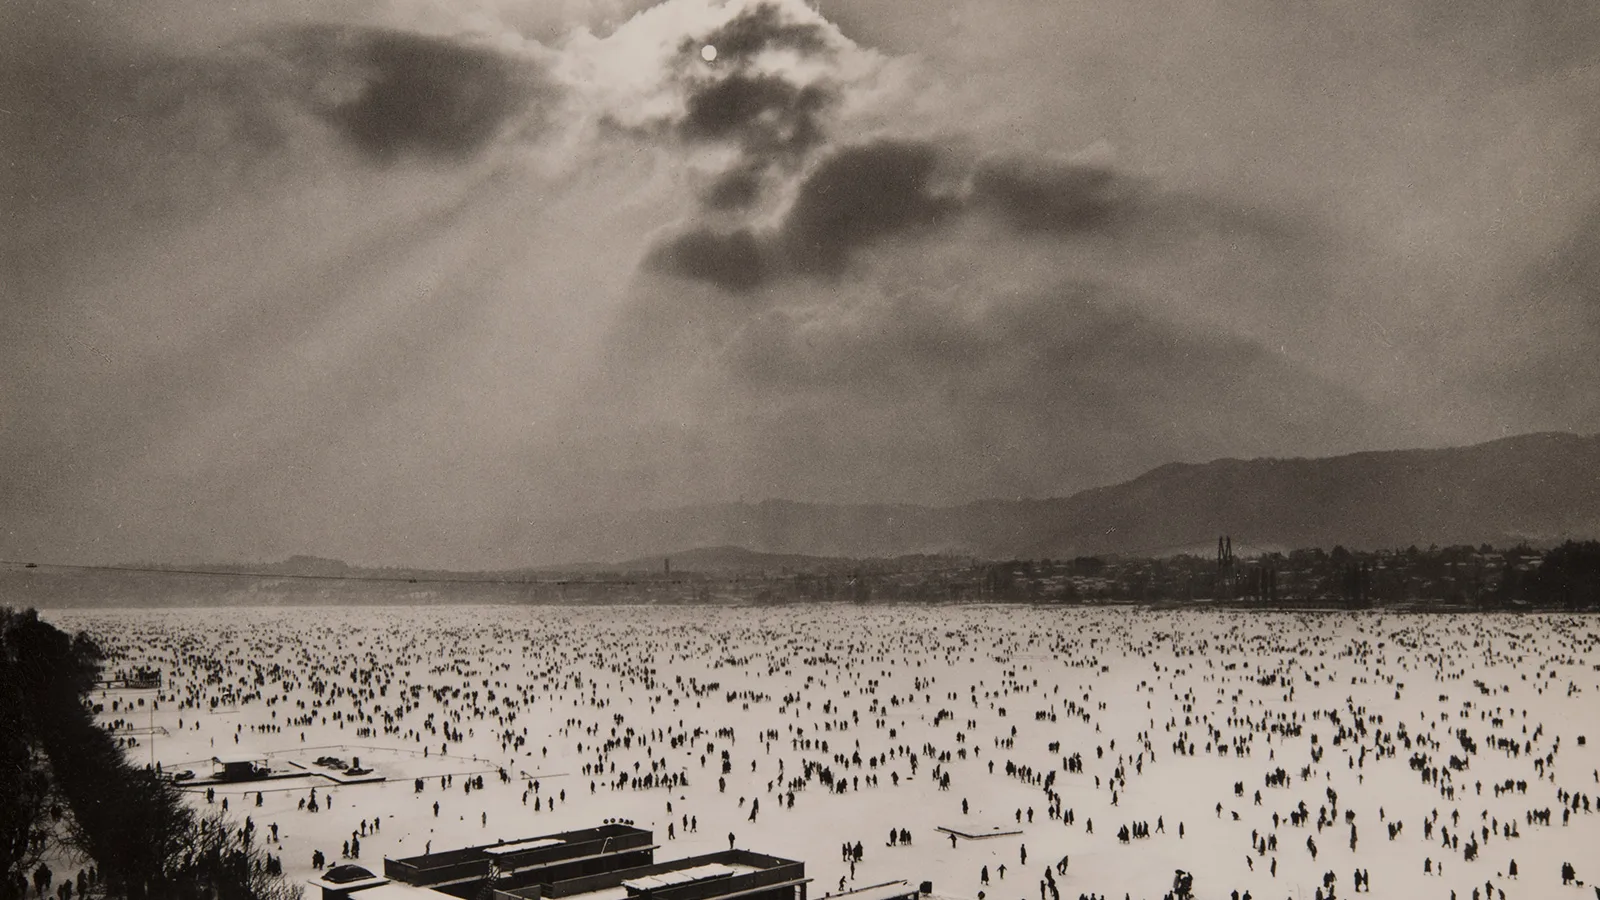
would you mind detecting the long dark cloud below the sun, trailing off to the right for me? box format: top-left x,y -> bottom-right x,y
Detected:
645,139 -> 1320,290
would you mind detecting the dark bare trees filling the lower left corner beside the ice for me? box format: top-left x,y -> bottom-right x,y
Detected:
0,607 -> 298,900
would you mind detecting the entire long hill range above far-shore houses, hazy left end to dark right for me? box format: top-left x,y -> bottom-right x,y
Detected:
512,434 -> 1600,565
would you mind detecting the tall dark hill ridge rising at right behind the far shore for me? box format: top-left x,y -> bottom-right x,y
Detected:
1018,434 -> 1600,554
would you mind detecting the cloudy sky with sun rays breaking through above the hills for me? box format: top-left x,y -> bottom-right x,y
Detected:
0,0 -> 1600,567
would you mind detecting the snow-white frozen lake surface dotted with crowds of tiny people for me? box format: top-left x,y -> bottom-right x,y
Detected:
45,605 -> 1600,900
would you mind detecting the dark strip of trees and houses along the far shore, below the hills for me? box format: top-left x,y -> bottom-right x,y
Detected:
601,536 -> 1600,609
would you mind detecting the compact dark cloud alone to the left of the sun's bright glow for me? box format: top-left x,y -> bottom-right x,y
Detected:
326,32 -> 530,160
